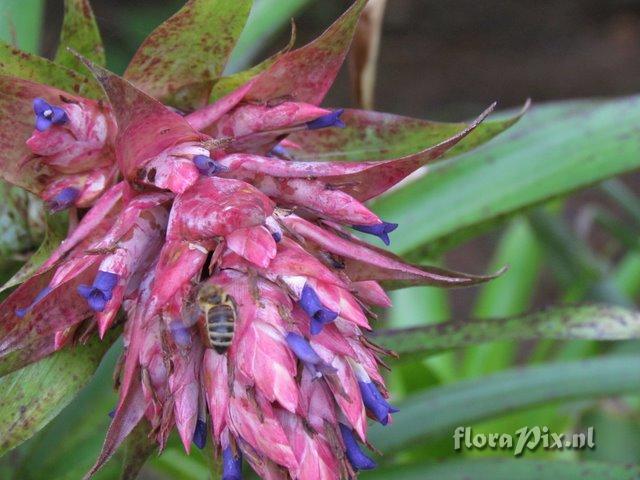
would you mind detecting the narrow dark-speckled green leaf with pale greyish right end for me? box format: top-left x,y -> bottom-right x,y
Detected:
370,305 -> 640,355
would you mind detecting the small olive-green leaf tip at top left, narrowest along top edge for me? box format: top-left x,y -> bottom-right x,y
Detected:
55,0 -> 106,72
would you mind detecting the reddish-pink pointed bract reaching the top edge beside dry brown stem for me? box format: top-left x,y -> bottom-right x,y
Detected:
247,0 -> 367,105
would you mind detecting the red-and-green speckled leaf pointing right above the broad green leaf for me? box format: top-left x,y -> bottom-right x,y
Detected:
288,101 -> 529,162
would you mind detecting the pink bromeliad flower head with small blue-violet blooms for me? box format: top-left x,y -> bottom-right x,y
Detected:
0,0 -> 510,480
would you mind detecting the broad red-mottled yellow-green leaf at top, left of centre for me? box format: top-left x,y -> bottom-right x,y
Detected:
125,0 -> 253,110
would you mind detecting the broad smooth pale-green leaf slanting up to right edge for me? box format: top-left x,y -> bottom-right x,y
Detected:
374,96 -> 640,256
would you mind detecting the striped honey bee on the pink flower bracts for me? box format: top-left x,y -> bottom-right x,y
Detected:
196,283 -> 237,354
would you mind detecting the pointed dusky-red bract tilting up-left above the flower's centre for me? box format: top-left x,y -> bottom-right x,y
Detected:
79,60 -> 204,180
